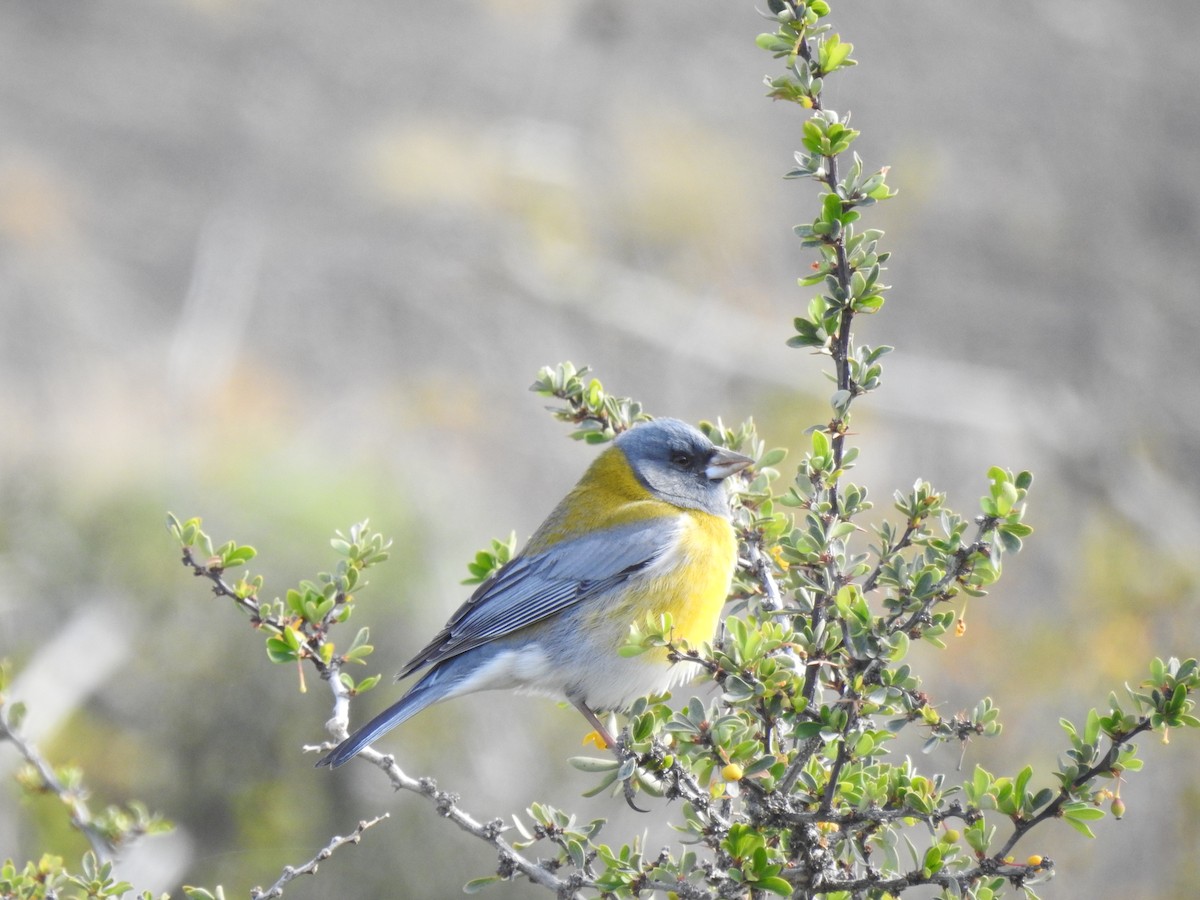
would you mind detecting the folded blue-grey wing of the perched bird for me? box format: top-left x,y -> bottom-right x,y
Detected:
398,516 -> 679,678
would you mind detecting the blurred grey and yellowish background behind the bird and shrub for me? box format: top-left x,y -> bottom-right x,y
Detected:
0,0 -> 1200,898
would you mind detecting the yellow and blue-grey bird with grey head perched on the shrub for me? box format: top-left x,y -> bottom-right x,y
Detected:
317,418 -> 754,768
